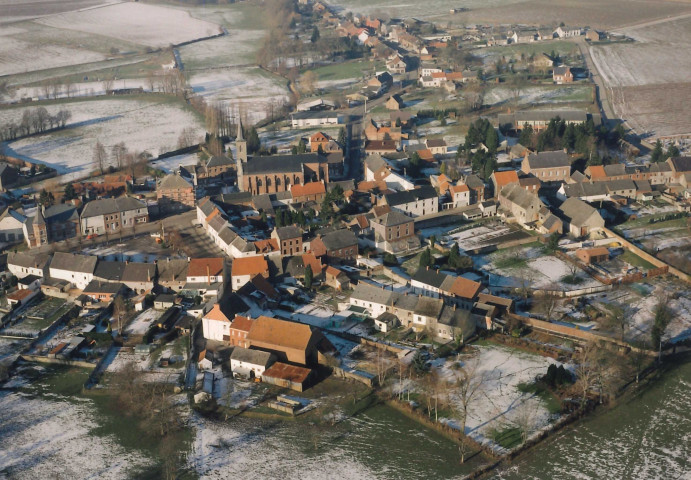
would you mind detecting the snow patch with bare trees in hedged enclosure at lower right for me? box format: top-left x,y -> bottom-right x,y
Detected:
436,346 -> 560,448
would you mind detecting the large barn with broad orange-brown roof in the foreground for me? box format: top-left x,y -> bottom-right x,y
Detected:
247,316 -> 330,366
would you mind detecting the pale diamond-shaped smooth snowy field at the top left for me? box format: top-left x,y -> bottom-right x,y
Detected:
37,2 -> 219,47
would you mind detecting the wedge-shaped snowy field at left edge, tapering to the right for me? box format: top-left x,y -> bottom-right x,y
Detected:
0,36 -> 105,76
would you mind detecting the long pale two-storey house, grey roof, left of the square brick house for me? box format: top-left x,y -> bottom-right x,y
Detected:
81,197 -> 149,235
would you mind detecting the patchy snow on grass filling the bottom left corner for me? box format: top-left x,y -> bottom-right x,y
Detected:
0,392 -> 152,480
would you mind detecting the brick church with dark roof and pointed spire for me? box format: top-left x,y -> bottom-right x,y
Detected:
235,124 -> 342,195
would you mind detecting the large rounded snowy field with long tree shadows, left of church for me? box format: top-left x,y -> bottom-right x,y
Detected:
0,97 -> 204,180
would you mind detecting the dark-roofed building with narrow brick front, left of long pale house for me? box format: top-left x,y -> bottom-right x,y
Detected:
22,203 -> 80,248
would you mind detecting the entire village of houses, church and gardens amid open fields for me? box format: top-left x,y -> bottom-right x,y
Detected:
0,0 -> 691,476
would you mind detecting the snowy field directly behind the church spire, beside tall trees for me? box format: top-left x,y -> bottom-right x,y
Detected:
189,67 -> 288,123
